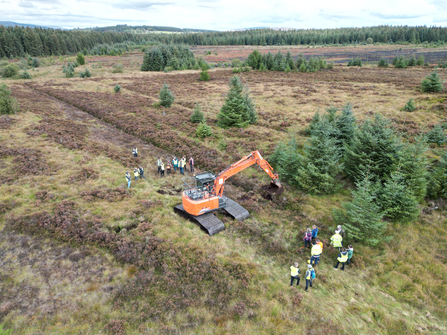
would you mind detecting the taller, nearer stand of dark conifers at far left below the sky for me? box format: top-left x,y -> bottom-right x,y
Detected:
0,26 -> 152,58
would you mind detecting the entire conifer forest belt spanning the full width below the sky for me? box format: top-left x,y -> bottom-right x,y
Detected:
0,26 -> 447,58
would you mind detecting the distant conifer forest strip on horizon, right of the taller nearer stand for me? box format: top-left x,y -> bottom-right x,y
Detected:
152,26 -> 447,45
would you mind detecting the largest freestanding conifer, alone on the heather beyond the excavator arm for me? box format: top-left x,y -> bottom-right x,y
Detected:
217,76 -> 257,128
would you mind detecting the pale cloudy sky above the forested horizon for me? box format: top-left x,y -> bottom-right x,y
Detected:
0,0 -> 447,30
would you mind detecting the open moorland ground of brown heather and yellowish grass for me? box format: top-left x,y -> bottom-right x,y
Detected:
0,46 -> 447,334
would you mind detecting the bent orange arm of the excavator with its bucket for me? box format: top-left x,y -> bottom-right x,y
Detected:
213,151 -> 282,196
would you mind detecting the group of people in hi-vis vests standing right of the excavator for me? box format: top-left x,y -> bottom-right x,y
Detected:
290,225 -> 354,291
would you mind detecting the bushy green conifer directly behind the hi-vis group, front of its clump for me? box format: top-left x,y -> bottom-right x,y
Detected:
332,175 -> 387,246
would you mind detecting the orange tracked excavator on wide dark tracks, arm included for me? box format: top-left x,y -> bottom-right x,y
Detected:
174,151 -> 284,236
